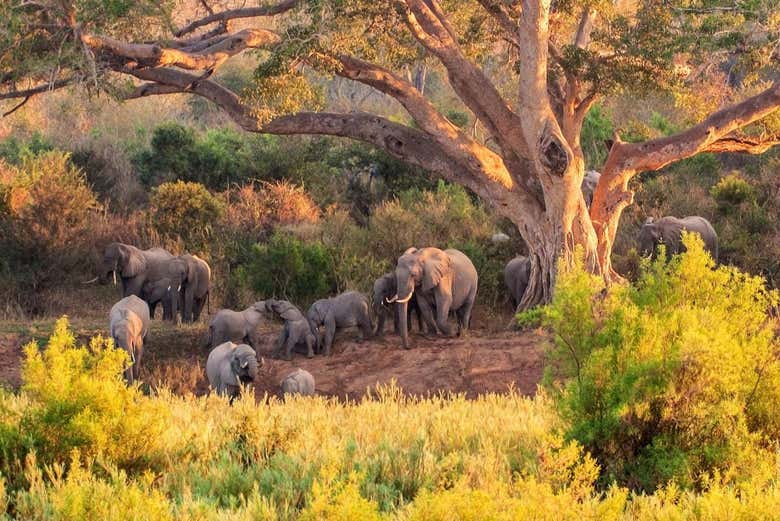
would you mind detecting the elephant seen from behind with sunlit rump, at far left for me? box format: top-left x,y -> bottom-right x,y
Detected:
108,295 -> 149,384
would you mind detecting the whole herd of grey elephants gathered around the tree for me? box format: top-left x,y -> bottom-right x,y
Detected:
89,176 -> 718,401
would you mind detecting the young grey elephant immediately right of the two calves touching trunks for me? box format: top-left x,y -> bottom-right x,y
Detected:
306,291 -> 374,356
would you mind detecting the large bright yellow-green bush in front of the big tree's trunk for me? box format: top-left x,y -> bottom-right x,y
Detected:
532,238 -> 780,491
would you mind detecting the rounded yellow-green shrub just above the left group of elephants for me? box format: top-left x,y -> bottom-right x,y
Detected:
149,181 -> 224,251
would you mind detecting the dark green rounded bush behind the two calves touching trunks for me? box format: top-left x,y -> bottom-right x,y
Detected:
242,231 -> 334,305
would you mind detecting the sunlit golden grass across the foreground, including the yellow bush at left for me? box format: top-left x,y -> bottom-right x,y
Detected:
0,320 -> 780,521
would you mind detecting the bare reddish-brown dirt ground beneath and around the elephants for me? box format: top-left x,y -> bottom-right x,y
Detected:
0,310 -> 546,399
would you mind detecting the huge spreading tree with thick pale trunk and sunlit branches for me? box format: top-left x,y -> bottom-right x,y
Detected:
0,0 -> 780,306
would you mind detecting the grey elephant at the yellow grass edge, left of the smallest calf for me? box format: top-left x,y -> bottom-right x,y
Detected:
206,342 -> 263,403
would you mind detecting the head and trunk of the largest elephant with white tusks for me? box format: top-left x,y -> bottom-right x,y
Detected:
387,248 -> 453,348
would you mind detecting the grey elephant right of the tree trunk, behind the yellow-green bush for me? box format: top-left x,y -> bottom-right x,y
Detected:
639,215 -> 718,262
